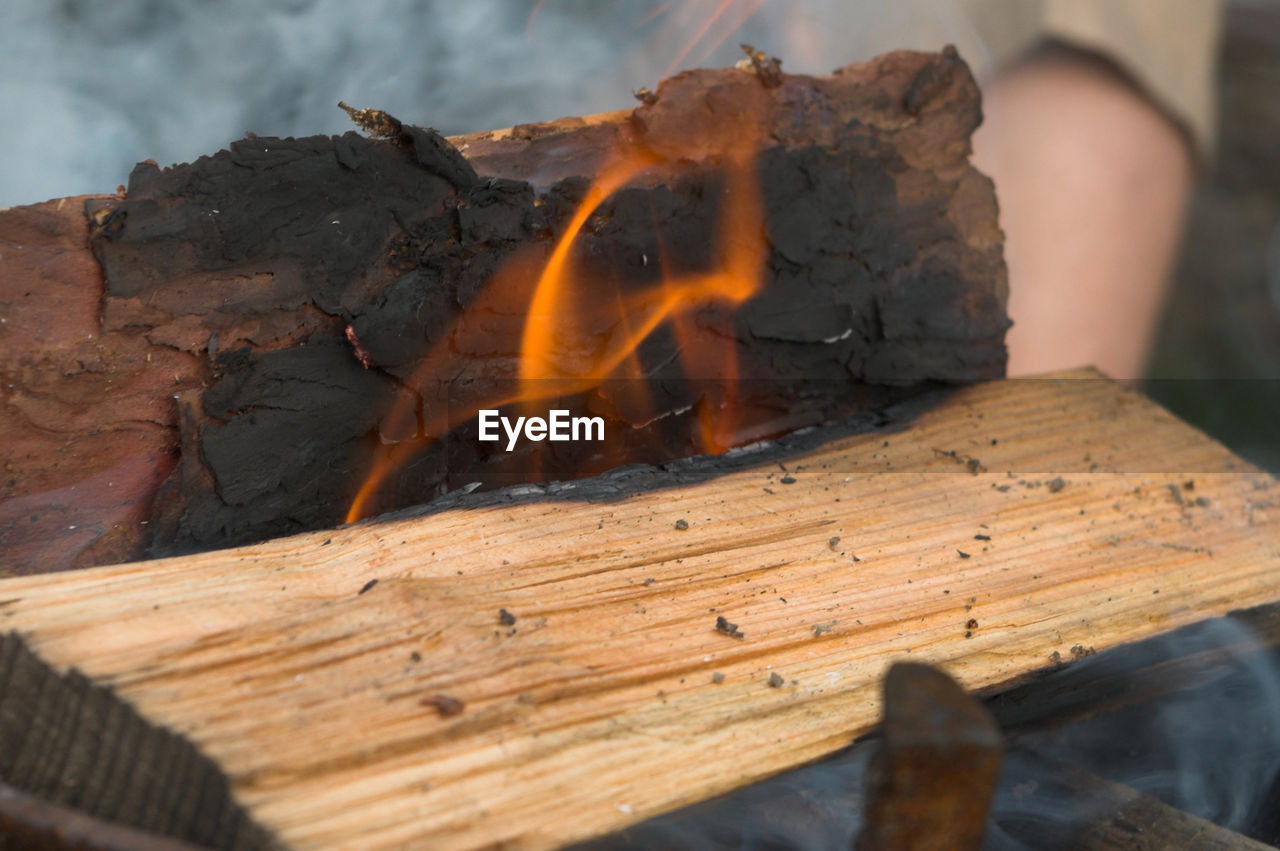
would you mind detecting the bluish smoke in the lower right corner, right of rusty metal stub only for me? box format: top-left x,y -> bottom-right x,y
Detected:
992,618 -> 1280,847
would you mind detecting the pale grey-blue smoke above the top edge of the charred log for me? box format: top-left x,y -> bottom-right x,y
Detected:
0,0 -> 984,207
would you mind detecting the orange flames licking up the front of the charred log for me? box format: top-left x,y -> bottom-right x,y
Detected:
346,143 -> 768,522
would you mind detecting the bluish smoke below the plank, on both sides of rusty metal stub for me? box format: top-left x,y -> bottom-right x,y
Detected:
577,618 -> 1280,851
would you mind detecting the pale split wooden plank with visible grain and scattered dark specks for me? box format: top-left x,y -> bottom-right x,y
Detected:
0,374 -> 1280,848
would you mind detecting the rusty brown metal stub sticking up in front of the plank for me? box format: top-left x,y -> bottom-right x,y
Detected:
854,663 -> 1002,851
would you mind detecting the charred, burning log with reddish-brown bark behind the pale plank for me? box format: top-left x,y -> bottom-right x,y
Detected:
0,44 -> 1007,563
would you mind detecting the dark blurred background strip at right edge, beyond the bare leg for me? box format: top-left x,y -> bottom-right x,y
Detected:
1144,0 -> 1280,472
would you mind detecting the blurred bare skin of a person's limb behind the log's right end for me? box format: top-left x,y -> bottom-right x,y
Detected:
974,47 -> 1193,379
